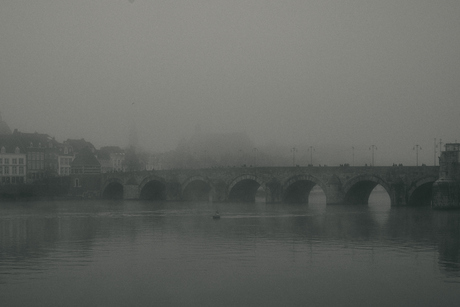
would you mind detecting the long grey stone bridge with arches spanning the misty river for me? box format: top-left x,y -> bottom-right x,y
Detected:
72,166 -> 439,206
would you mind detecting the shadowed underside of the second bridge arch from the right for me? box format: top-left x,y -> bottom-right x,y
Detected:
343,174 -> 394,205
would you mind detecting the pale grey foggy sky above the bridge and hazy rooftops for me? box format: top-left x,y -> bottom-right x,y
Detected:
0,0 -> 460,165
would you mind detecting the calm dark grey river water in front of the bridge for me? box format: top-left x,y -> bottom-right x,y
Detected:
0,189 -> 460,306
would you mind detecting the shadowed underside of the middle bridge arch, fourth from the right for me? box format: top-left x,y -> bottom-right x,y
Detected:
228,174 -> 264,202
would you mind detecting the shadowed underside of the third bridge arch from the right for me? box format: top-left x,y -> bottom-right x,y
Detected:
283,174 -> 326,203
